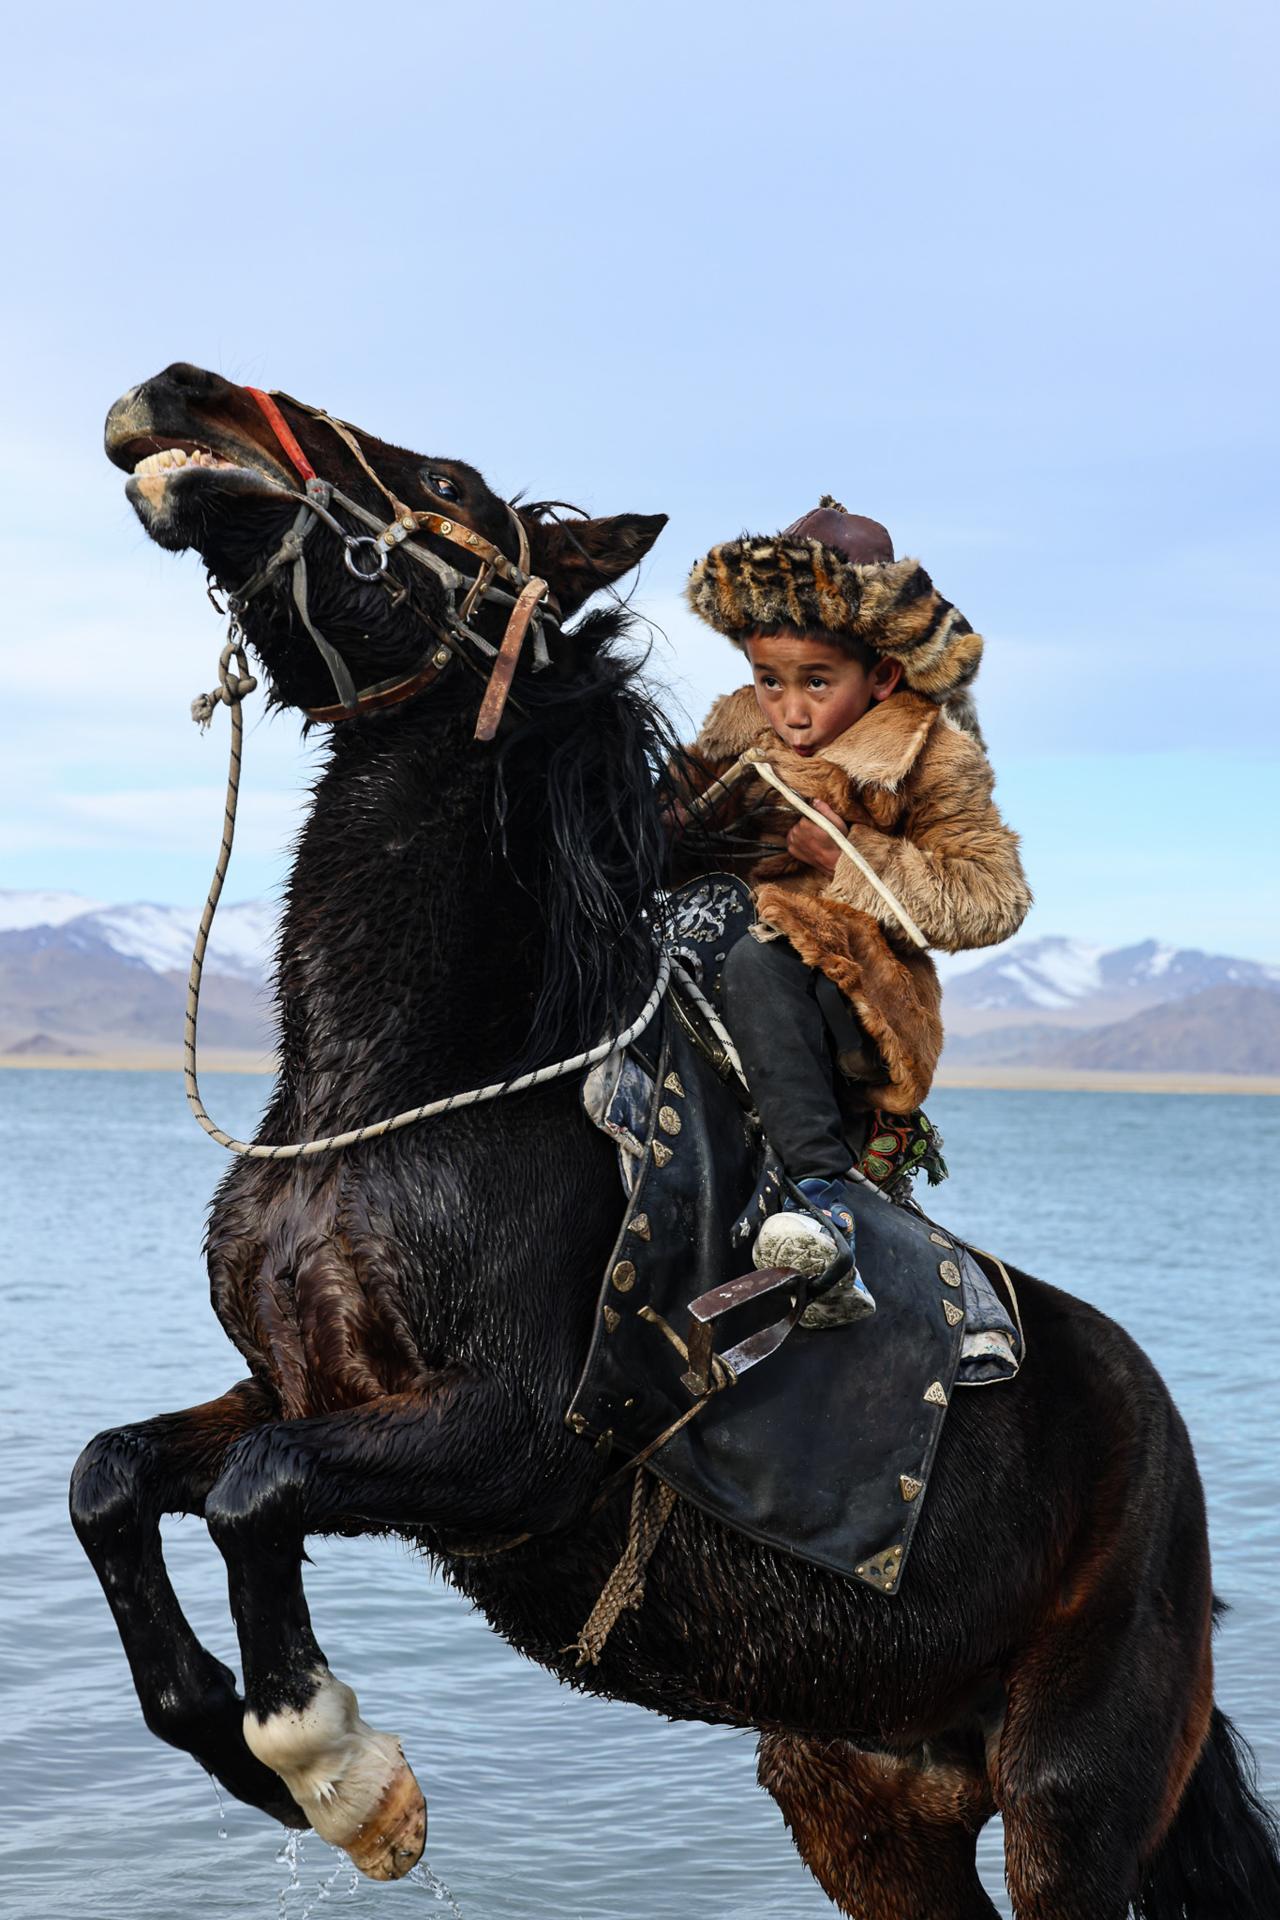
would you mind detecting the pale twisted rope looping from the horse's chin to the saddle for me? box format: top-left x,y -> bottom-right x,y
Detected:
182,648 -> 672,1160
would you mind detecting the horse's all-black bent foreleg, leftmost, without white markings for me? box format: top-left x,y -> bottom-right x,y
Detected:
71,1380 -> 307,1826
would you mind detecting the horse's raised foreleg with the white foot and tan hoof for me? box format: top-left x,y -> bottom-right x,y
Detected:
205,1375 -> 585,1880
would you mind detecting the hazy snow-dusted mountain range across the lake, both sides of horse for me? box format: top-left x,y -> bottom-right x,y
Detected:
0,891 -> 1280,1073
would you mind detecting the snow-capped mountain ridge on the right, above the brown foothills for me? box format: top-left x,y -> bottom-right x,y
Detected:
942,935 -> 1280,1020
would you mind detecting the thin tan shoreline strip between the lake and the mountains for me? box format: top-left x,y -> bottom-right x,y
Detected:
0,1046 -> 1280,1096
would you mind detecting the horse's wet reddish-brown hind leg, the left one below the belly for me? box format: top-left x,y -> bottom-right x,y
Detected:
760,1734 -> 996,1920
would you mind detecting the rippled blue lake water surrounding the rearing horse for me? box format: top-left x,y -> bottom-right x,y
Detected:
0,1071 -> 1280,1920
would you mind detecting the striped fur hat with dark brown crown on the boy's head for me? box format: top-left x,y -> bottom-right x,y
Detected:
685,493 -> 983,743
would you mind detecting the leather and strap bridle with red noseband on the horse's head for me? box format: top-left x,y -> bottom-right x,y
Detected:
226,386 -> 560,741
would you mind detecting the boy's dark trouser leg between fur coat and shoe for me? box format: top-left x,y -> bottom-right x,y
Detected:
723,933 -> 856,1181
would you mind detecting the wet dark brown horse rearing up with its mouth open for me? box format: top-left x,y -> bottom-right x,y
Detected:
73,365 -> 1280,1920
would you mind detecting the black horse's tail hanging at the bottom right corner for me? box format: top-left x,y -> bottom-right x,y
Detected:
1134,1707 -> 1280,1920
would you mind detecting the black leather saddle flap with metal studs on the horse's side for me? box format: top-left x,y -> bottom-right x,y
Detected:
566,1013 -> 963,1594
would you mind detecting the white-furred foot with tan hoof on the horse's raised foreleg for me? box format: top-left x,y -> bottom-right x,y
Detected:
244,1668 -> 426,1880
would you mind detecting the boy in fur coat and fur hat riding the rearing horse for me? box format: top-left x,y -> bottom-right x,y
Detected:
687,495 -> 1031,1325
